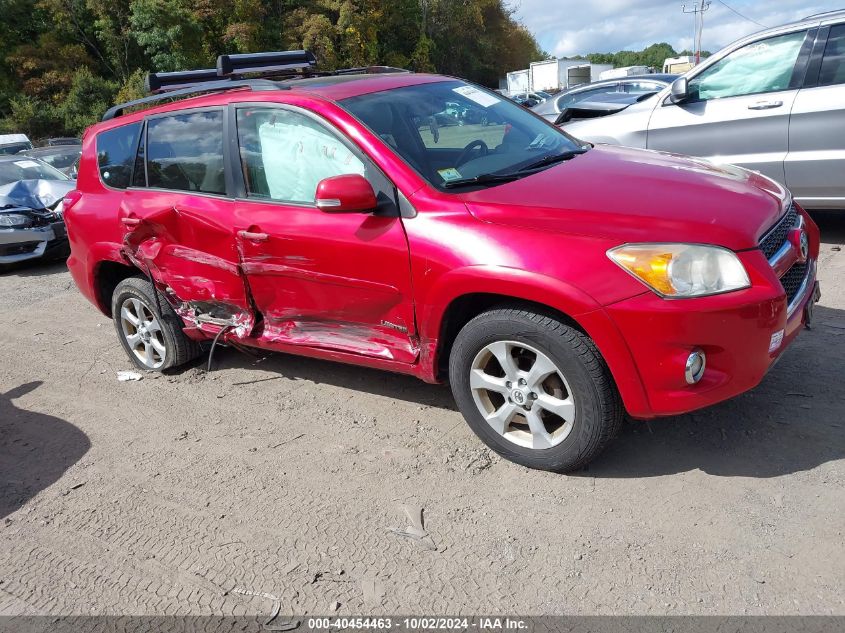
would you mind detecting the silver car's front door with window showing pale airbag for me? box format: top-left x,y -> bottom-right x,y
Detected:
647,30 -> 814,183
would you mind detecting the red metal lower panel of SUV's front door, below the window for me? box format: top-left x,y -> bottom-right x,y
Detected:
236,200 -> 419,363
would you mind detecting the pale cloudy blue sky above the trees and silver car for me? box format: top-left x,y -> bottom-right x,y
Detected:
510,0 -> 845,57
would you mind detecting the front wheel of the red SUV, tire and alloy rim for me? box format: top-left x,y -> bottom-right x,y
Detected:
449,307 -> 624,472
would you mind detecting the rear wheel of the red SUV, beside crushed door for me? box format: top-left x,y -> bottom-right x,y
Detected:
112,277 -> 201,371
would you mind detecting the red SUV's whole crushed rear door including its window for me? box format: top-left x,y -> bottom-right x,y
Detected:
120,108 -> 253,332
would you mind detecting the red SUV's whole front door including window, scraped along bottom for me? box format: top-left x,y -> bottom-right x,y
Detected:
235,106 -> 419,363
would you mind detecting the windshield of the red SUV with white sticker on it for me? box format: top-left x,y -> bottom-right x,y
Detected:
340,81 -> 582,189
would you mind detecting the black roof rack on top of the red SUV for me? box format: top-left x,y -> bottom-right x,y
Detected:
103,50 -> 411,121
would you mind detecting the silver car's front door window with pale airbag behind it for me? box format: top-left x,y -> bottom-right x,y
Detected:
689,31 -> 807,101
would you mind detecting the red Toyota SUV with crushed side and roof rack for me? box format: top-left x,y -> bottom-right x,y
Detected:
65,52 -> 819,471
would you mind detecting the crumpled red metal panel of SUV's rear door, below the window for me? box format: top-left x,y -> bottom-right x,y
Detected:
120,189 -> 254,335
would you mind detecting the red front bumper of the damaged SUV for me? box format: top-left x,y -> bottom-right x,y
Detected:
605,247 -> 820,418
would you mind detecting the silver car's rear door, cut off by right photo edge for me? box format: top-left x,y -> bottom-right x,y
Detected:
785,24 -> 845,209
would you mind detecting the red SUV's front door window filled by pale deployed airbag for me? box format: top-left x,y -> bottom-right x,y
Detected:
237,108 -> 366,204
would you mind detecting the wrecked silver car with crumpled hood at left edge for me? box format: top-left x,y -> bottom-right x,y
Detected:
0,156 -> 75,269
